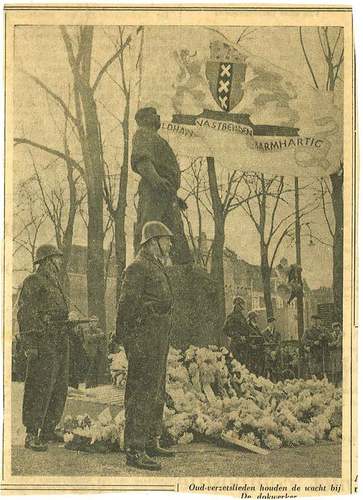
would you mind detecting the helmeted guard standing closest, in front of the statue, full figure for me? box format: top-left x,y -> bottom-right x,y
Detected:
116,221 -> 174,470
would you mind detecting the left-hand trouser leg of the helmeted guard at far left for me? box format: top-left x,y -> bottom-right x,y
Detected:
22,349 -> 58,432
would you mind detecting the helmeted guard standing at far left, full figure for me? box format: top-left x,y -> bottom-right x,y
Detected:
17,245 -> 69,451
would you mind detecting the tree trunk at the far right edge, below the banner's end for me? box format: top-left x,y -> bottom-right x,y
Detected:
330,172 -> 344,322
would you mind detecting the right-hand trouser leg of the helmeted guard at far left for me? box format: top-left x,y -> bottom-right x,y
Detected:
42,347 -> 69,432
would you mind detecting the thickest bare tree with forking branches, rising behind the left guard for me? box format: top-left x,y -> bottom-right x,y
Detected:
15,26 -> 134,327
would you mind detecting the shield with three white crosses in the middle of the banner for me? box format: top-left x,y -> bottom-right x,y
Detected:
206,41 -> 247,112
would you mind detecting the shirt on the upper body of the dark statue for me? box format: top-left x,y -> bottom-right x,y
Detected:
131,127 -> 181,195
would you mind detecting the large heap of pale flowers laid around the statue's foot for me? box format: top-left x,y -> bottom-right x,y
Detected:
65,346 -> 342,449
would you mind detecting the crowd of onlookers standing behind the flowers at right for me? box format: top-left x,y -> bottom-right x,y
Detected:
223,296 -> 343,384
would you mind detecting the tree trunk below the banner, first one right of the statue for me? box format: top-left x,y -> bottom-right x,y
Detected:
207,157 -> 226,334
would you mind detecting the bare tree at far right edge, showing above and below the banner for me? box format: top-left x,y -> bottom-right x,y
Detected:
299,26 -> 344,321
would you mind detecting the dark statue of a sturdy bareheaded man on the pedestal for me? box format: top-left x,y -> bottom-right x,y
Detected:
131,107 -> 192,264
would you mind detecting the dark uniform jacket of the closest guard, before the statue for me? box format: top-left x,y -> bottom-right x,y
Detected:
115,249 -> 173,341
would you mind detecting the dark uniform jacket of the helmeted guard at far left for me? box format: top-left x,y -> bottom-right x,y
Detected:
17,267 -> 69,349
